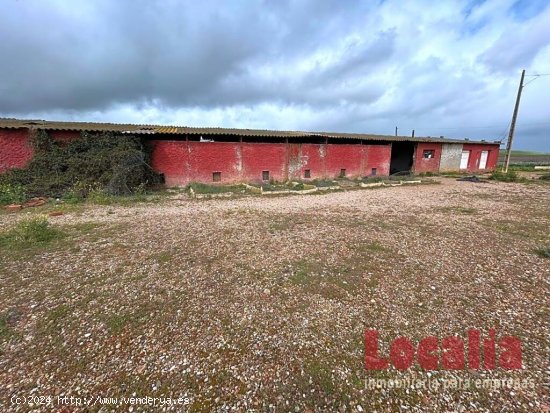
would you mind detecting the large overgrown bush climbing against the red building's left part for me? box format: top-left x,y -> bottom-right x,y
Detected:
0,131 -> 160,200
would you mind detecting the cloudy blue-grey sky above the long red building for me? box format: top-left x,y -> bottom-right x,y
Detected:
0,0 -> 550,152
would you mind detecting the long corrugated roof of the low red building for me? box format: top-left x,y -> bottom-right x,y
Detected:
0,118 -> 499,144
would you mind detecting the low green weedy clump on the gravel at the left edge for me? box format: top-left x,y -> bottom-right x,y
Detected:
0,216 -> 64,248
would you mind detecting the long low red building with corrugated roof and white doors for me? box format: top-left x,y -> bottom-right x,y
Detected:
0,119 -> 499,186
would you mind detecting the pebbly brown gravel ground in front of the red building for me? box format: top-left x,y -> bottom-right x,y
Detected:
0,178 -> 550,412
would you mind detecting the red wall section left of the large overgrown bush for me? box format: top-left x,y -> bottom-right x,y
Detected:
0,129 -> 34,173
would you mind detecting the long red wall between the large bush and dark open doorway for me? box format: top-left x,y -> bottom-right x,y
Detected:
152,140 -> 391,186
